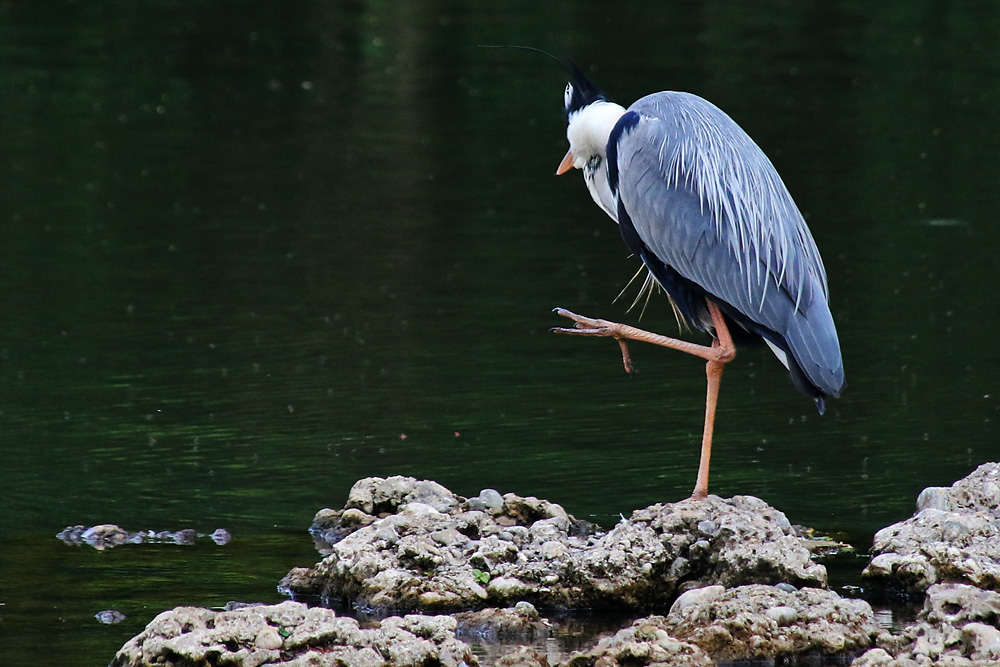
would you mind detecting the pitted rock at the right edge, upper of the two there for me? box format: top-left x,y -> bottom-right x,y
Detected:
863,463 -> 1000,593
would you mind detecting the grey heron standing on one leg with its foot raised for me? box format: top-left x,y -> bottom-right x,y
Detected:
553,65 -> 844,499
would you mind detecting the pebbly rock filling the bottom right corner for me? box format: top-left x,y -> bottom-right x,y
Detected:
852,584 -> 1000,667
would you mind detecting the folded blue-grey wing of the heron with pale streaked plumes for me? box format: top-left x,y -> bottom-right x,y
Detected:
617,93 -> 844,396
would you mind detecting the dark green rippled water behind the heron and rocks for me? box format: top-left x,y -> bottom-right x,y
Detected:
0,1 -> 1000,666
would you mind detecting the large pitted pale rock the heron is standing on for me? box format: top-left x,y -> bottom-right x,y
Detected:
279,477 -> 826,611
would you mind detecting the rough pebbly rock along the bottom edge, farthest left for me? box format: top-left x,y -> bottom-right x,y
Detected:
111,601 -> 478,667
